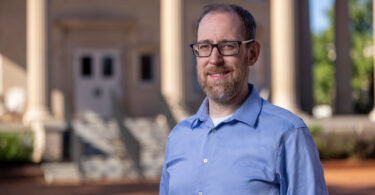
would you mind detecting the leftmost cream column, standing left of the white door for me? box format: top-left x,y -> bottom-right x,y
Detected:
23,0 -> 50,124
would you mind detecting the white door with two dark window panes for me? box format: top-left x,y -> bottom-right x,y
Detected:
74,49 -> 121,118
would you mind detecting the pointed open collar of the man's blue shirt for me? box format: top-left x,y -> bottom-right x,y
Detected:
191,84 -> 262,129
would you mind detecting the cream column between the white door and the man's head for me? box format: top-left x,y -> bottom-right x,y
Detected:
161,0 -> 183,104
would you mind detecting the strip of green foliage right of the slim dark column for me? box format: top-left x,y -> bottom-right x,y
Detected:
349,0 -> 373,113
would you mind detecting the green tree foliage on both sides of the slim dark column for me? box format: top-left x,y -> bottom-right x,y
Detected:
313,0 -> 373,113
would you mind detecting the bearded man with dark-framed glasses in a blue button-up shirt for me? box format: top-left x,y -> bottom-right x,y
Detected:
160,4 -> 328,195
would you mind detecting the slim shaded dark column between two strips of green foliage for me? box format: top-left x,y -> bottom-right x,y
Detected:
335,0 -> 353,114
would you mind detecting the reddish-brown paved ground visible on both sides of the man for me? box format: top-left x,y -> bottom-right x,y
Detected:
0,160 -> 375,195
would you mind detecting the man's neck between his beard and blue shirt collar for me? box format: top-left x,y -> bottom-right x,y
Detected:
208,83 -> 250,117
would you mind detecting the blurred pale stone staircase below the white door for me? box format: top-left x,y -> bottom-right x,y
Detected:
73,113 -> 169,180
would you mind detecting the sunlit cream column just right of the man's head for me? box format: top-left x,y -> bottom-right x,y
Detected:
271,0 -> 299,112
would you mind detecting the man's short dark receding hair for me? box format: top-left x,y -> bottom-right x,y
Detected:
195,3 -> 256,40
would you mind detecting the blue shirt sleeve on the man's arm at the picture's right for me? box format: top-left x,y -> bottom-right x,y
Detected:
279,127 -> 328,195
